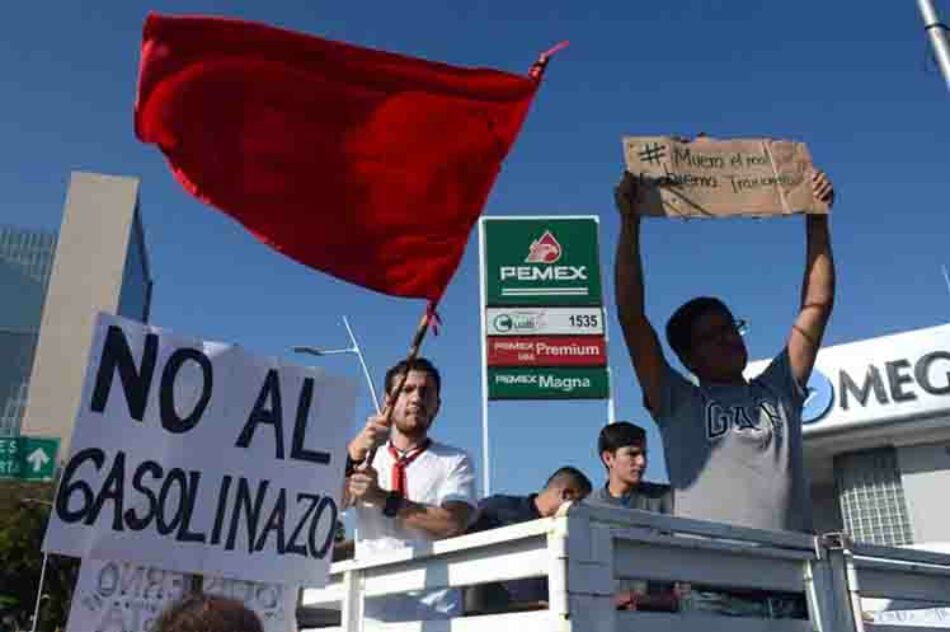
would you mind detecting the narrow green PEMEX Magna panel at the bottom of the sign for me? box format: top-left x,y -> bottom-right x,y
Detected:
488,367 -> 610,399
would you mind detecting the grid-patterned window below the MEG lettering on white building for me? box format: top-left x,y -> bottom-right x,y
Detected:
834,447 -> 914,546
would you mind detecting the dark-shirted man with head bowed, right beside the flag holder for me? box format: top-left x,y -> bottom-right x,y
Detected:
465,466 -> 591,614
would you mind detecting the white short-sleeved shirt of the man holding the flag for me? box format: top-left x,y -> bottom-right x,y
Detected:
354,441 -> 476,621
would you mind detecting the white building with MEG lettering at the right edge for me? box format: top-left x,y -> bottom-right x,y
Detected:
750,325 -> 950,548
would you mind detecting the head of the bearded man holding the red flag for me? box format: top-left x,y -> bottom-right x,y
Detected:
386,358 -> 442,437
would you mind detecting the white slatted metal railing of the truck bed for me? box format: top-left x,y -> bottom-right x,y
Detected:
303,503 -> 950,632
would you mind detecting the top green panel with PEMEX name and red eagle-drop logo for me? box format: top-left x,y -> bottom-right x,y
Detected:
482,217 -> 603,306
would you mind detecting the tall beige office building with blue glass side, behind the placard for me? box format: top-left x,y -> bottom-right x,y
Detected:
20,173 -> 152,452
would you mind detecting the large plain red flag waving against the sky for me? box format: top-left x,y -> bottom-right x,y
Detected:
135,14 -> 546,302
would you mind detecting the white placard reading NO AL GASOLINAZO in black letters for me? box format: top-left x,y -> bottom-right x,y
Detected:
44,314 -> 356,586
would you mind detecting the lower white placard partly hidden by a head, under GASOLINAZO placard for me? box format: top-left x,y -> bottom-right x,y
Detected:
66,559 -> 297,632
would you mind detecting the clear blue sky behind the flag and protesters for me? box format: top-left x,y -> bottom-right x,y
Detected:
0,0 -> 950,493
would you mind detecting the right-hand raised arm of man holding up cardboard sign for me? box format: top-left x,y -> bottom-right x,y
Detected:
788,172 -> 835,385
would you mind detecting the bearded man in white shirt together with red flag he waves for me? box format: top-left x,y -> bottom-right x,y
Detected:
135,14 -> 566,619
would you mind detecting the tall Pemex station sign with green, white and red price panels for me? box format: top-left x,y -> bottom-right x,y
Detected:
479,216 -> 610,400
